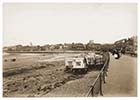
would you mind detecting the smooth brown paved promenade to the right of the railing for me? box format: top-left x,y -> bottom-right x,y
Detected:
103,55 -> 137,97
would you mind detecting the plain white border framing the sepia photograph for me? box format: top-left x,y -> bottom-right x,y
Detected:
0,0 -> 140,100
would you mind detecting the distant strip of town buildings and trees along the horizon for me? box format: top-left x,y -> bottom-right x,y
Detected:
3,36 -> 137,52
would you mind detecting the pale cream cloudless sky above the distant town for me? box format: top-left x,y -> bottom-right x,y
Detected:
3,3 -> 137,46
